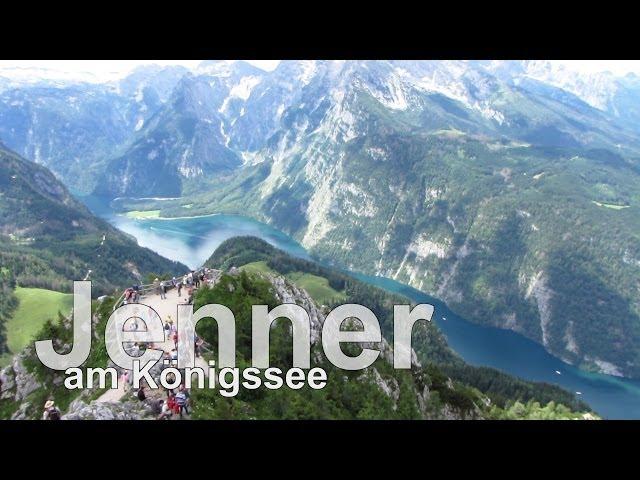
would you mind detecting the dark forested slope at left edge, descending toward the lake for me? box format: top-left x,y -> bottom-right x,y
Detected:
0,147 -> 188,296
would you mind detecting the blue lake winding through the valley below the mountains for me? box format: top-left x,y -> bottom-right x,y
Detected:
83,199 -> 640,419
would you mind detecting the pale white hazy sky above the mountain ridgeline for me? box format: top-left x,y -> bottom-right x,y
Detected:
0,60 -> 640,80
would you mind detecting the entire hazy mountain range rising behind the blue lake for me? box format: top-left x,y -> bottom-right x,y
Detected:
0,61 -> 640,377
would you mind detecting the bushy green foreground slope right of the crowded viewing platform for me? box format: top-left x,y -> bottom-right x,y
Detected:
192,271 -> 585,420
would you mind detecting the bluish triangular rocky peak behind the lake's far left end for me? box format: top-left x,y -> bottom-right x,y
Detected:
96,76 -> 241,197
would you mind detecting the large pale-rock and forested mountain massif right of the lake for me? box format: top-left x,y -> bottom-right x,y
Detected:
166,62 -> 640,376
